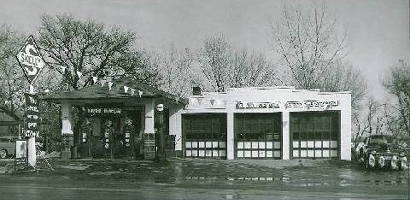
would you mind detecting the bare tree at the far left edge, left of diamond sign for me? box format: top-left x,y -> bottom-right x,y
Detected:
0,25 -> 28,120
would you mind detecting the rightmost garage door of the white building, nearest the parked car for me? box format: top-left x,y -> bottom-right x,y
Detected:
290,111 -> 340,158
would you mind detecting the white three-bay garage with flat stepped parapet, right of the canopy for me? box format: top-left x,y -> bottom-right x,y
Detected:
170,87 -> 351,160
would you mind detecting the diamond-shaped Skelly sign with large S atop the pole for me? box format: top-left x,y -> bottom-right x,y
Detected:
16,36 -> 45,84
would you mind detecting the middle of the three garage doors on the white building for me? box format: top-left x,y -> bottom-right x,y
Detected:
234,113 -> 282,159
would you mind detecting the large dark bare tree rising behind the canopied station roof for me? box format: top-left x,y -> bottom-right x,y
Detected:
39,15 -> 160,90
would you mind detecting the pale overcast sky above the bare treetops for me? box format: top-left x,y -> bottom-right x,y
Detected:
0,0 -> 410,99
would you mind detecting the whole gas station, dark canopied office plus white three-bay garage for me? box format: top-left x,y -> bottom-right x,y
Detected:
45,83 -> 351,160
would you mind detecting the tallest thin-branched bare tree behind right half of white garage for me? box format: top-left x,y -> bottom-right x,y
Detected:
272,4 -> 366,109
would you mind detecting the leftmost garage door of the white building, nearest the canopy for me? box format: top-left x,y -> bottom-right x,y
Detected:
182,113 -> 226,158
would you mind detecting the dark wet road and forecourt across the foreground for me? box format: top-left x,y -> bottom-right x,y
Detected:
0,159 -> 408,200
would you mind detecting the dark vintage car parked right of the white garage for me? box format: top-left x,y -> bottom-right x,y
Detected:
359,135 -> 408,170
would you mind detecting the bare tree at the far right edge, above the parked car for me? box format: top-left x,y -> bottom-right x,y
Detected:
383,60 -> 410,137
